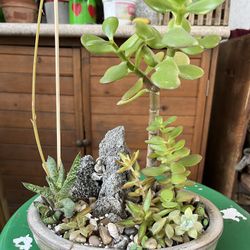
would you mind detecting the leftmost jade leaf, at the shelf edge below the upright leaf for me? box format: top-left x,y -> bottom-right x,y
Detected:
81,34 -> 115,54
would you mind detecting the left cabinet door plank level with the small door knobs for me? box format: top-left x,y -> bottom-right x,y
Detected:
0,128 -> 75,147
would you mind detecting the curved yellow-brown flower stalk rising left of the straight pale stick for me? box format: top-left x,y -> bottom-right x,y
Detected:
31,0 -> 48,175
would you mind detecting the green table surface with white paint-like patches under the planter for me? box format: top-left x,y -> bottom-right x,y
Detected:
0,184 -> 250,250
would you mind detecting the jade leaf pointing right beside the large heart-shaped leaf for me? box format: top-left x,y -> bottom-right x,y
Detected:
178,65 -> 204,80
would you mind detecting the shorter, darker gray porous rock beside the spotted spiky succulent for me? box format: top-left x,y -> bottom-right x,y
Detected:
72,155 -> 101,200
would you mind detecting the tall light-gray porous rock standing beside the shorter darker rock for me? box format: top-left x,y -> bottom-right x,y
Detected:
93,126 -> 129,218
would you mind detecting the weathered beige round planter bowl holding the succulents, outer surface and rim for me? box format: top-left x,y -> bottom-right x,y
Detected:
27,193 -> 223,250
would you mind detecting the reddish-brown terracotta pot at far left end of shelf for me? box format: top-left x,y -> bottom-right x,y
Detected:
0,0 -> 37,23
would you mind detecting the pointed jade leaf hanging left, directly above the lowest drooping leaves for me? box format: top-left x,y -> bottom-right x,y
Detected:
100,62 -> 129,84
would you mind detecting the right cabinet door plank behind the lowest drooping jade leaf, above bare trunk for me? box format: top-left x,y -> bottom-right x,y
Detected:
91,76 -> 199,97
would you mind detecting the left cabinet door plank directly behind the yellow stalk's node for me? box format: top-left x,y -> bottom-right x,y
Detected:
0,111 -> 75,130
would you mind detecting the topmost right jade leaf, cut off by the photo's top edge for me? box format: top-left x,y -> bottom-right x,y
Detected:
186,0 -> 225,15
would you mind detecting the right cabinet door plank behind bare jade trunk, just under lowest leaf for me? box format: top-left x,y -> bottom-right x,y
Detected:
91,97 -> 197,116
